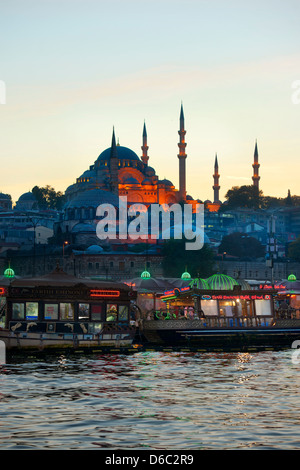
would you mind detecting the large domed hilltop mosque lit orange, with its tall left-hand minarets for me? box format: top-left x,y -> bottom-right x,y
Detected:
56,105 -> 206,242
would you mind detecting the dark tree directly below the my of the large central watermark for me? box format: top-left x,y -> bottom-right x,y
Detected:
162,239 -> 214,278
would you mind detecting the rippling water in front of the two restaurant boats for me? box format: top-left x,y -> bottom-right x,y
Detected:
0,350 -> 300,451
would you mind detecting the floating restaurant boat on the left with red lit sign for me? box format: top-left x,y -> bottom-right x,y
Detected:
0,267 -> 135,352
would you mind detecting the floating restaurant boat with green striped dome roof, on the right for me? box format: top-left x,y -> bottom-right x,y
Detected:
140,274 -> 300,351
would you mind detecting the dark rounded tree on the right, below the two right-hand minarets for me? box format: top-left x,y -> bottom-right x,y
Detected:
218,232 -> 265,258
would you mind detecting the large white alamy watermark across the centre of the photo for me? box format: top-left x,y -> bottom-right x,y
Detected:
96,196 -> 204,250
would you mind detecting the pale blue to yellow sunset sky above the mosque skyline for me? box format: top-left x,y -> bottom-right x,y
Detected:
0,0 -> 300,201
